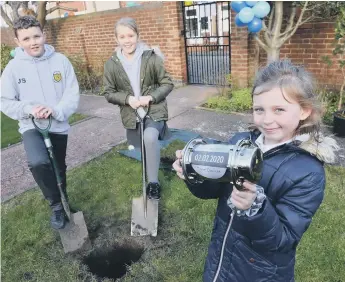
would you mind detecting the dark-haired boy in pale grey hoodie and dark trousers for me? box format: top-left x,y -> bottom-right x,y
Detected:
1,16 -> 79,229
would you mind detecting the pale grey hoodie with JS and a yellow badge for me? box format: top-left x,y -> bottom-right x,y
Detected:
1,44 -> 79,134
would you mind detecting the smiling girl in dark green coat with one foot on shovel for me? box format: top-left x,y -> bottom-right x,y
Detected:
104,18 -> 174,200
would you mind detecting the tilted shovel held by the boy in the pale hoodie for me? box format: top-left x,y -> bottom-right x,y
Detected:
31,115 -> 91,253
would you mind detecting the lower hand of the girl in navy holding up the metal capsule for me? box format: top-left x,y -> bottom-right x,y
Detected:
231,180 -> 256,210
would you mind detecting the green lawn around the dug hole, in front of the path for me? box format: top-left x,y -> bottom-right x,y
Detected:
1,145 -> 345,282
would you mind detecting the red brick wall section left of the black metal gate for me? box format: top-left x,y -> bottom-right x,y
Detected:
45,2 -> 187,83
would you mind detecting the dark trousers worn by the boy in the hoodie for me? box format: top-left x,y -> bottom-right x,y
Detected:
23,129 -> 68,206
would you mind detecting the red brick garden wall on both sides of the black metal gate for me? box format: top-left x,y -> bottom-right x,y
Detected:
1,1 -> 341,87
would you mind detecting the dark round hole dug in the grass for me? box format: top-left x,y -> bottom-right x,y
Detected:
83,243 -> 144,279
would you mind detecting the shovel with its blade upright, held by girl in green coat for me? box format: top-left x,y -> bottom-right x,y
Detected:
131,107 -> 158,237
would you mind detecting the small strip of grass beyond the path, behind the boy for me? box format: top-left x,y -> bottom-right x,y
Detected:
1,113 -> 86,149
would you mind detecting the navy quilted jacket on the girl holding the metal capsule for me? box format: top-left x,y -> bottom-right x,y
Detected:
187,133 -> 325,282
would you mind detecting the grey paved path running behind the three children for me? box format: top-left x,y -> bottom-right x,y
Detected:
1,86 -> 345,201
